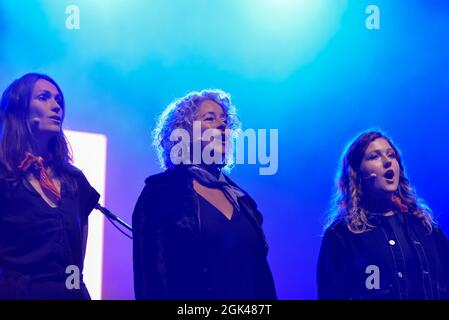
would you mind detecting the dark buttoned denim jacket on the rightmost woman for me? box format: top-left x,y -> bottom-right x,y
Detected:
317,213 -> 449,300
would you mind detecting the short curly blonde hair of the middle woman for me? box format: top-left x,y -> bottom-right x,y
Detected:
153,89 -> 241,172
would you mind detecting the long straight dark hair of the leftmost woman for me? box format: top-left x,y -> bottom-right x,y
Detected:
0,73 -> 75,189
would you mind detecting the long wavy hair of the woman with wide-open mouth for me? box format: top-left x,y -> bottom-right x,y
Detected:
326,130 -> 433,233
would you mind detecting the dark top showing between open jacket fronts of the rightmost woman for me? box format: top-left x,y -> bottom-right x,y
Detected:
385,212 -> 424,300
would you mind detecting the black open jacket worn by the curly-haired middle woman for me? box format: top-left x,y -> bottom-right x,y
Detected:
133,166 -> 276,300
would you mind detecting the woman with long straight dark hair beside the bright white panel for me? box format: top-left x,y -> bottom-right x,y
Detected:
0,73 -> 99,299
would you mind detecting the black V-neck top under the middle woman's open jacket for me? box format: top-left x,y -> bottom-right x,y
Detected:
199,195 -> 264,299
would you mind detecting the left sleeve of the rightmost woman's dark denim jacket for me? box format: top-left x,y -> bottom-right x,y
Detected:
317,228 -> 351,300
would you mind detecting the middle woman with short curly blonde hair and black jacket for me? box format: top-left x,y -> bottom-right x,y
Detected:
133,90 -> 276,299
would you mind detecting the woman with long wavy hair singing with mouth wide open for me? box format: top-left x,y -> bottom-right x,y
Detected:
317,130 -> 449,300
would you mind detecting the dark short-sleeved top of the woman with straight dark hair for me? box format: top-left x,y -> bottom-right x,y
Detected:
0,171 -> 100,299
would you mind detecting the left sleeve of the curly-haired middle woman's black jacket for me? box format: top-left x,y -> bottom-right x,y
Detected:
132,183 -> 168,300
